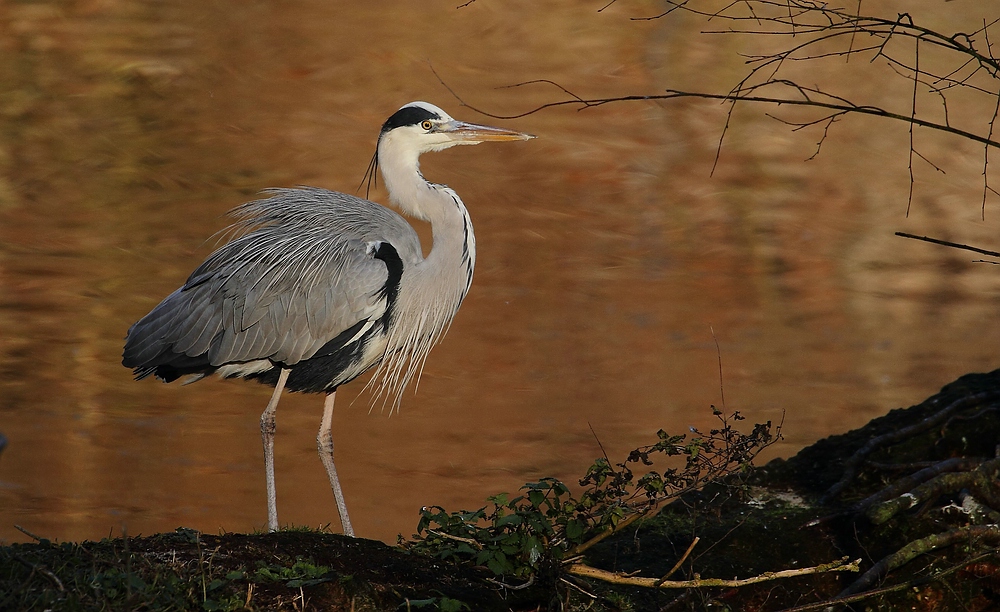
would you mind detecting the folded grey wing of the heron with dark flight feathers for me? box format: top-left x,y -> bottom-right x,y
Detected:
122,188 -> 421,380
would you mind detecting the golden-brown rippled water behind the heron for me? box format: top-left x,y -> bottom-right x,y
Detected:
0,0 -> 1000,541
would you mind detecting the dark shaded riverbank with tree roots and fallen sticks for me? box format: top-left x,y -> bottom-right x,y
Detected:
0,371 -> 1000,611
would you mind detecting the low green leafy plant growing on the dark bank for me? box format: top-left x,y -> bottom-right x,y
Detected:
407,406 -> 781,580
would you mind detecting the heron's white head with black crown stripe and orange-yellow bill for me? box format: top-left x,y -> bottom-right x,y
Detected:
378,102 -> 534,155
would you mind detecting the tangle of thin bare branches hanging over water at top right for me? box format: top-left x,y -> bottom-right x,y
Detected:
453,0 -> 1000,220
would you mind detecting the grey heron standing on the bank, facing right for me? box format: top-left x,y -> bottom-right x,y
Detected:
122,102 -> 533,536
